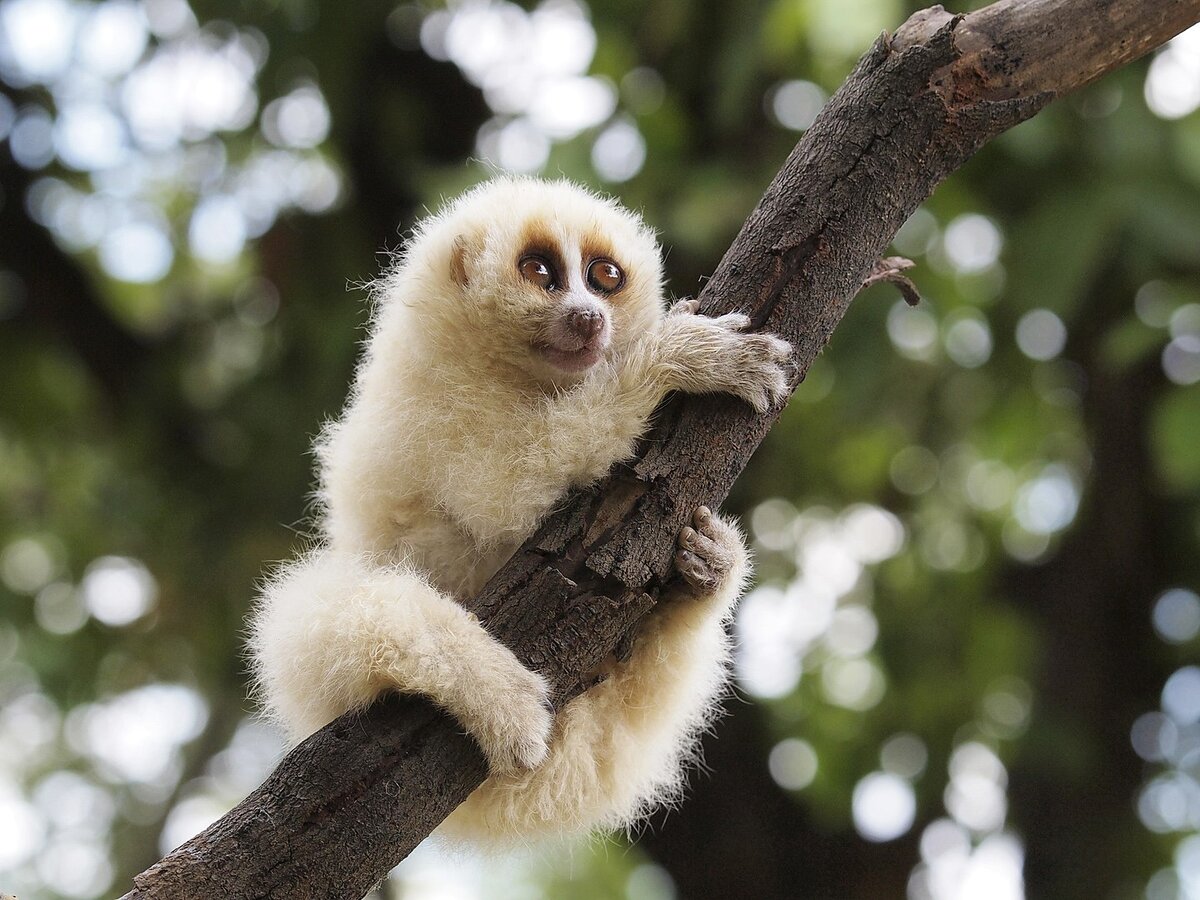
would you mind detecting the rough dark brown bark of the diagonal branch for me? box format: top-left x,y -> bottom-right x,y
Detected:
117,0 -> 1200,900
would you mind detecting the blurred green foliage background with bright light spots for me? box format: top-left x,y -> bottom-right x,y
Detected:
0,0 -> 1200,900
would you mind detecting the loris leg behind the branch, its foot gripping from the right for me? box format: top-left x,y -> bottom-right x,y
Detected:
442,508 -> 750,842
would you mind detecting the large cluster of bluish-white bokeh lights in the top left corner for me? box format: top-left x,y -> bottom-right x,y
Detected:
0,0 -> 343,284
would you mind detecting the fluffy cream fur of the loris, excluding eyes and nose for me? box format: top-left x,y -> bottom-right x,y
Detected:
251,179 -> 788,845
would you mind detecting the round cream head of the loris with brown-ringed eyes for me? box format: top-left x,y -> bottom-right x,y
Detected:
384,178 -> 662,385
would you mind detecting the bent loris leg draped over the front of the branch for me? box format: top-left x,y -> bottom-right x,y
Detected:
250,550 -> 552,772
